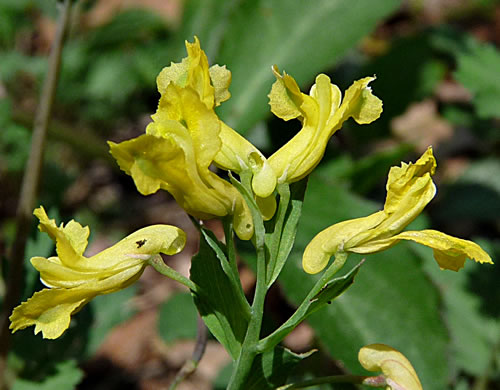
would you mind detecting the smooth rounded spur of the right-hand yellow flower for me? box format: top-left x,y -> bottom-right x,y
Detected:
302,211 -> 385,274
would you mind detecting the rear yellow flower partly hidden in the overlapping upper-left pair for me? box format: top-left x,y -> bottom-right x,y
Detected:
156,37 -> 276,198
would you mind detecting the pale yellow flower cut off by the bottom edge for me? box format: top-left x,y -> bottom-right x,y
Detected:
358,344 -> 422,390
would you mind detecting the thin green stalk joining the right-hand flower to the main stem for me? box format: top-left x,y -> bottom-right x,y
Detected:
257,252 -> 347,353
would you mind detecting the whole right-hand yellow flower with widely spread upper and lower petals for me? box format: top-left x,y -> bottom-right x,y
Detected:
302,148 -> 492,274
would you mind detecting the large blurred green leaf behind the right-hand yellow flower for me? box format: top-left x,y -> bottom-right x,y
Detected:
279,161 -> 450,390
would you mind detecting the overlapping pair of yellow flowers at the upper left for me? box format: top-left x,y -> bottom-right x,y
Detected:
109,38 -> 276,235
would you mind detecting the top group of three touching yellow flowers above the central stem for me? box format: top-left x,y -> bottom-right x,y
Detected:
109,38 -> 382,240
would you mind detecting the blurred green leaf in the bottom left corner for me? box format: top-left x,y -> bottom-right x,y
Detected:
11,360 -> 83,390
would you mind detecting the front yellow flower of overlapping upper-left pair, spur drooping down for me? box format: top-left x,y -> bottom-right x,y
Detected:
108,84 -> 253,240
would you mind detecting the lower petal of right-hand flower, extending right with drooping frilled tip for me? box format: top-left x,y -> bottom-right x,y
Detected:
394,230 -> 493,271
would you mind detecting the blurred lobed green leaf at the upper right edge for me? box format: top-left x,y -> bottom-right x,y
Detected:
454,39 -> 500,118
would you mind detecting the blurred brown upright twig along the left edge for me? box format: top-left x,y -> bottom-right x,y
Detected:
0,0 -> 71,389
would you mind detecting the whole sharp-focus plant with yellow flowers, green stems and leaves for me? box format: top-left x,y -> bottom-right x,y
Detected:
11,38 -> 491,390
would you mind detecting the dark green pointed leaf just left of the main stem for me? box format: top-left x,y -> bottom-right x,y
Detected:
191,230 -> 249,359
